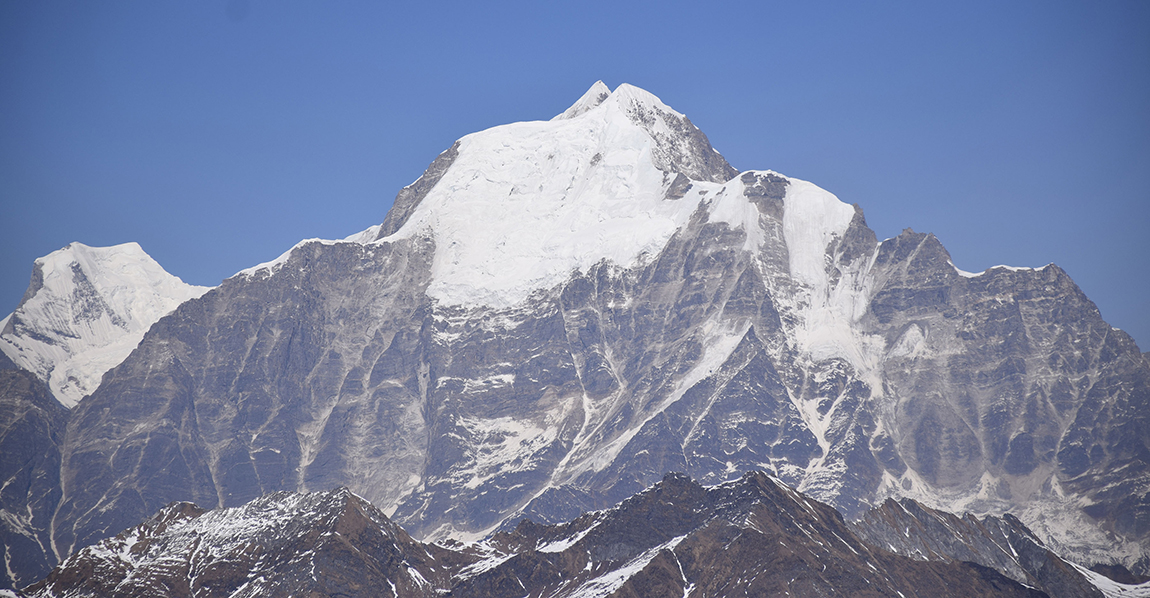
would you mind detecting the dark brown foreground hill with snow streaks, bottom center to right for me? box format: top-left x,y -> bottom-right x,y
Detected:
454,473 -> 1045,597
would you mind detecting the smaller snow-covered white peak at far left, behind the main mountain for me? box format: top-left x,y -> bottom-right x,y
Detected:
0,243 -> 208,407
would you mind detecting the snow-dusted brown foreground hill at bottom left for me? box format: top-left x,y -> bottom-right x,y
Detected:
25,489 -> 453,598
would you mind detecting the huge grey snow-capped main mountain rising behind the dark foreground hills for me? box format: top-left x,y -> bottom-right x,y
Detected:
0,83 -> 1150,585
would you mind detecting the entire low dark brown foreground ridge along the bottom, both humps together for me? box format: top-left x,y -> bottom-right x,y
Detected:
25,473 -> 1053,598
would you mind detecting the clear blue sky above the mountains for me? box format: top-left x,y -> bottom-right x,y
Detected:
0,0 -> 1150,351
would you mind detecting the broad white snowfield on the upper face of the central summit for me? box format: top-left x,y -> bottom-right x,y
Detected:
374,82 -> 734,308
